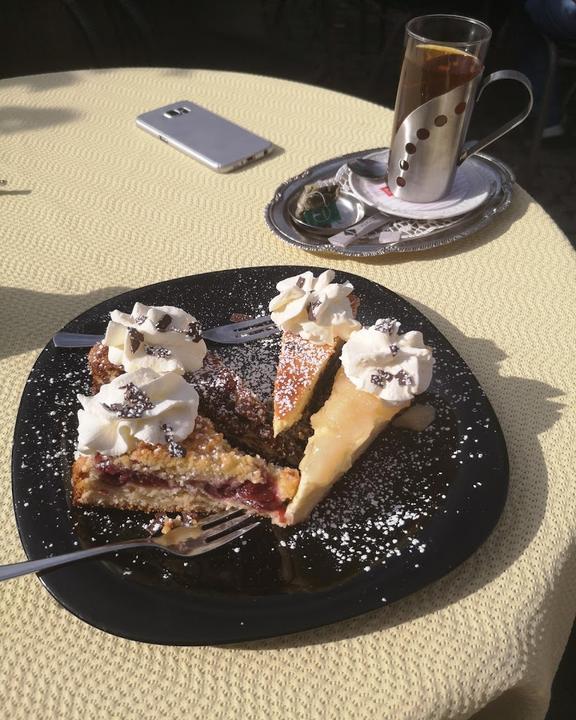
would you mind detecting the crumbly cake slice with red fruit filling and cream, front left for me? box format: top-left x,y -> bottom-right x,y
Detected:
72,368 -> 299,524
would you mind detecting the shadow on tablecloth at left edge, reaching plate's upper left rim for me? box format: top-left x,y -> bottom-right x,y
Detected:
0,287 -> 130,360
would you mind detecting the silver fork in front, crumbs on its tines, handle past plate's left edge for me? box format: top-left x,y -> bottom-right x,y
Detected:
0,510 -> 260,580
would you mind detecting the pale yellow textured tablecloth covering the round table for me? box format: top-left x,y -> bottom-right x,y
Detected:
0,69 -> 576,720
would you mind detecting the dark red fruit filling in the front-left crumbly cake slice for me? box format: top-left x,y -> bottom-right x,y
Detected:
95,454 -> 286,512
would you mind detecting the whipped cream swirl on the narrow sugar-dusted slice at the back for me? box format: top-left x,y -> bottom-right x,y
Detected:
269,270 -> 361,344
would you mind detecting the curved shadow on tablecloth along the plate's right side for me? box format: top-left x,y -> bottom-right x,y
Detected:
236,298 -> 564,650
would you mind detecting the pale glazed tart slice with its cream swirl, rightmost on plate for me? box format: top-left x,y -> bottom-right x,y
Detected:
286,318 -> 434,525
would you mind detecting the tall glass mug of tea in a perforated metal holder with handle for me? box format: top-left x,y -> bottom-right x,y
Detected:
388,15 -> 533,202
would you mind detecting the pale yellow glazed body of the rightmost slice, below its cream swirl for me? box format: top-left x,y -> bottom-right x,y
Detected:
286,368 -> 410,525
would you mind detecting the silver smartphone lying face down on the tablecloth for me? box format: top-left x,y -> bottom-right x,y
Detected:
136,100 -> 274,172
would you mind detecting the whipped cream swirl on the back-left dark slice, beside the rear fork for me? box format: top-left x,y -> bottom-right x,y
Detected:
104,303 -> 206,375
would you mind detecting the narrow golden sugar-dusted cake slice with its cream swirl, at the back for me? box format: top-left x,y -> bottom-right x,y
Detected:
269,270 -> 361,435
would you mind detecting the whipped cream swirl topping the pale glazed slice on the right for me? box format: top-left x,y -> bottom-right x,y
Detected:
341,318 -> 434,405
